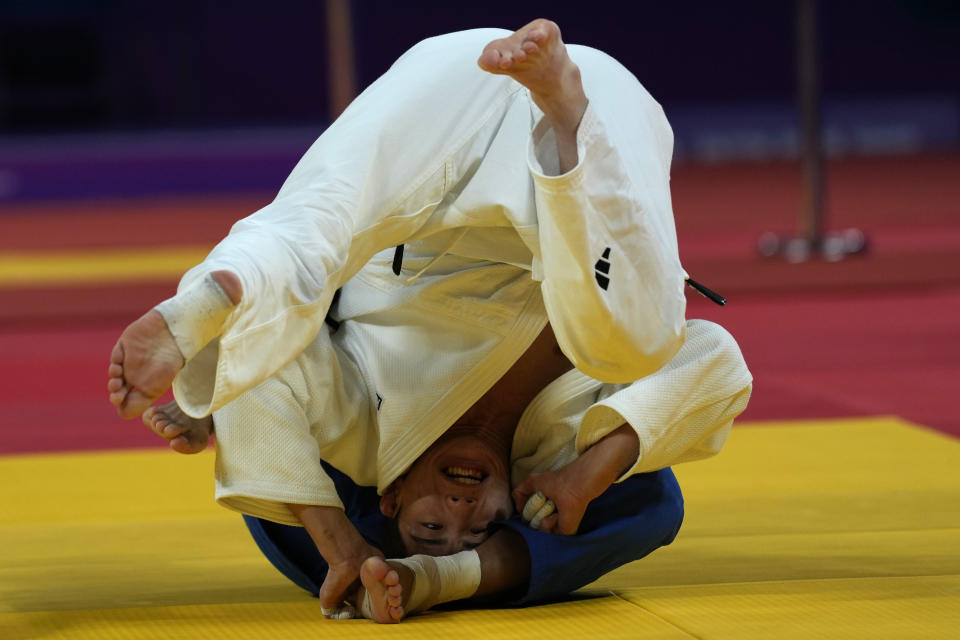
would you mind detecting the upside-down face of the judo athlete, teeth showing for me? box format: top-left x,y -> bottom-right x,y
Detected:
380,436 -> 513,556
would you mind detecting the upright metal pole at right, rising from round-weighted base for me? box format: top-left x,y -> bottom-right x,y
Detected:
796,0 -> 824,253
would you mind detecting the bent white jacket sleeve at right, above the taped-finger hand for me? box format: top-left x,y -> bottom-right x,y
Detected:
576,320 -> 753,480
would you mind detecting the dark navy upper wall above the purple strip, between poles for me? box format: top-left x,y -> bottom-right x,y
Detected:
0,0 -> 960,135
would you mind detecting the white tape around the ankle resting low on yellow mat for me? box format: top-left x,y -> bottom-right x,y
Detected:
358,549 -> 480,619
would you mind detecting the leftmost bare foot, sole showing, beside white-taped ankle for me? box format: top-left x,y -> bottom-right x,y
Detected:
107,309 -> 184,418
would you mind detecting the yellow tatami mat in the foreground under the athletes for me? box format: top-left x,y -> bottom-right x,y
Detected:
0,418 -> 960,640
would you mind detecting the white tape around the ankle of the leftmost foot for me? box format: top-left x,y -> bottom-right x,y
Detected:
154,274 -> 234,361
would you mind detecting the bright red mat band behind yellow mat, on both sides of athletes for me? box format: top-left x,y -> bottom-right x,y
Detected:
0,288 -> 960,453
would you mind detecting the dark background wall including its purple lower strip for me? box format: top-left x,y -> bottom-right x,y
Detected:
0,0 -> 960,202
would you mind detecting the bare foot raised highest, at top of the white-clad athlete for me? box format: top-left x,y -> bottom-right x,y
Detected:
477,18 -> 587,132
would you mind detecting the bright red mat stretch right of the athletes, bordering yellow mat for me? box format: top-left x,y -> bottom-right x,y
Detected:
688,287 -> 960,436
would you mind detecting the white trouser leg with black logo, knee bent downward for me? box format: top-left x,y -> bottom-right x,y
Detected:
528,48 -> 686,383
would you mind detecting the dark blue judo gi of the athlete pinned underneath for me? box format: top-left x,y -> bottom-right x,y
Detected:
243,464 -> 683,606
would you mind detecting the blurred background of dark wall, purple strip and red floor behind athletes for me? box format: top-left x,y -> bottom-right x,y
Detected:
0,0 -> 960,453
